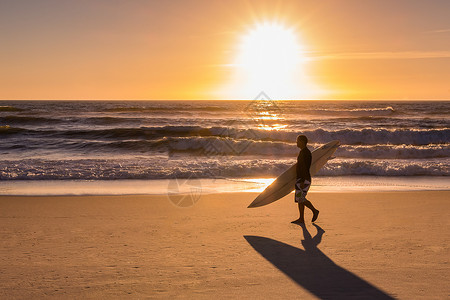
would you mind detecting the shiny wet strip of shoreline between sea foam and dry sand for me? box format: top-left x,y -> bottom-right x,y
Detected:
0,176 -> 450,196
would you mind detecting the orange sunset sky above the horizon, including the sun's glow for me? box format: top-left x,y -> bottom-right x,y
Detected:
0,0 -> 450,100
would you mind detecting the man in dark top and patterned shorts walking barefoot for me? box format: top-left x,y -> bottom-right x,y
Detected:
292,135 -> 319,224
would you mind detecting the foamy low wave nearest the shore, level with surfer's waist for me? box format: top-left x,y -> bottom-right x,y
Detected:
0,157 -> 450,180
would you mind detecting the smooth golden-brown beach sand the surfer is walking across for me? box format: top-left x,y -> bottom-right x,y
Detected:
0,191 -> 450,299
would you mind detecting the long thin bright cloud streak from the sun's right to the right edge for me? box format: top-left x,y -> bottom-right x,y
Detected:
307,51 -> 450,60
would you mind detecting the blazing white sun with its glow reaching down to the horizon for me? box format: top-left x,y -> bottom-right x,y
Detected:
221,22 -> 315,99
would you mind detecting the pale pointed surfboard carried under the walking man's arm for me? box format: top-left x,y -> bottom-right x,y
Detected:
248,141 -> 339,208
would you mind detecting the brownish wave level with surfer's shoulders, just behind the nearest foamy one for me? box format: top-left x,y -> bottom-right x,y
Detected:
0,136 -> 450,159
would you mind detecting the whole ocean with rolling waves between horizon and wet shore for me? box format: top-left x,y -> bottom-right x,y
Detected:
0,99 -> 450,195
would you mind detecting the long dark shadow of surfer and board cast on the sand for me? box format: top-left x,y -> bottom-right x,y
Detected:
244,224 -> 394,299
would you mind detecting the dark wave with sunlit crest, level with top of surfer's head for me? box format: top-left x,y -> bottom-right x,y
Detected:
0,126 -> 450,145
